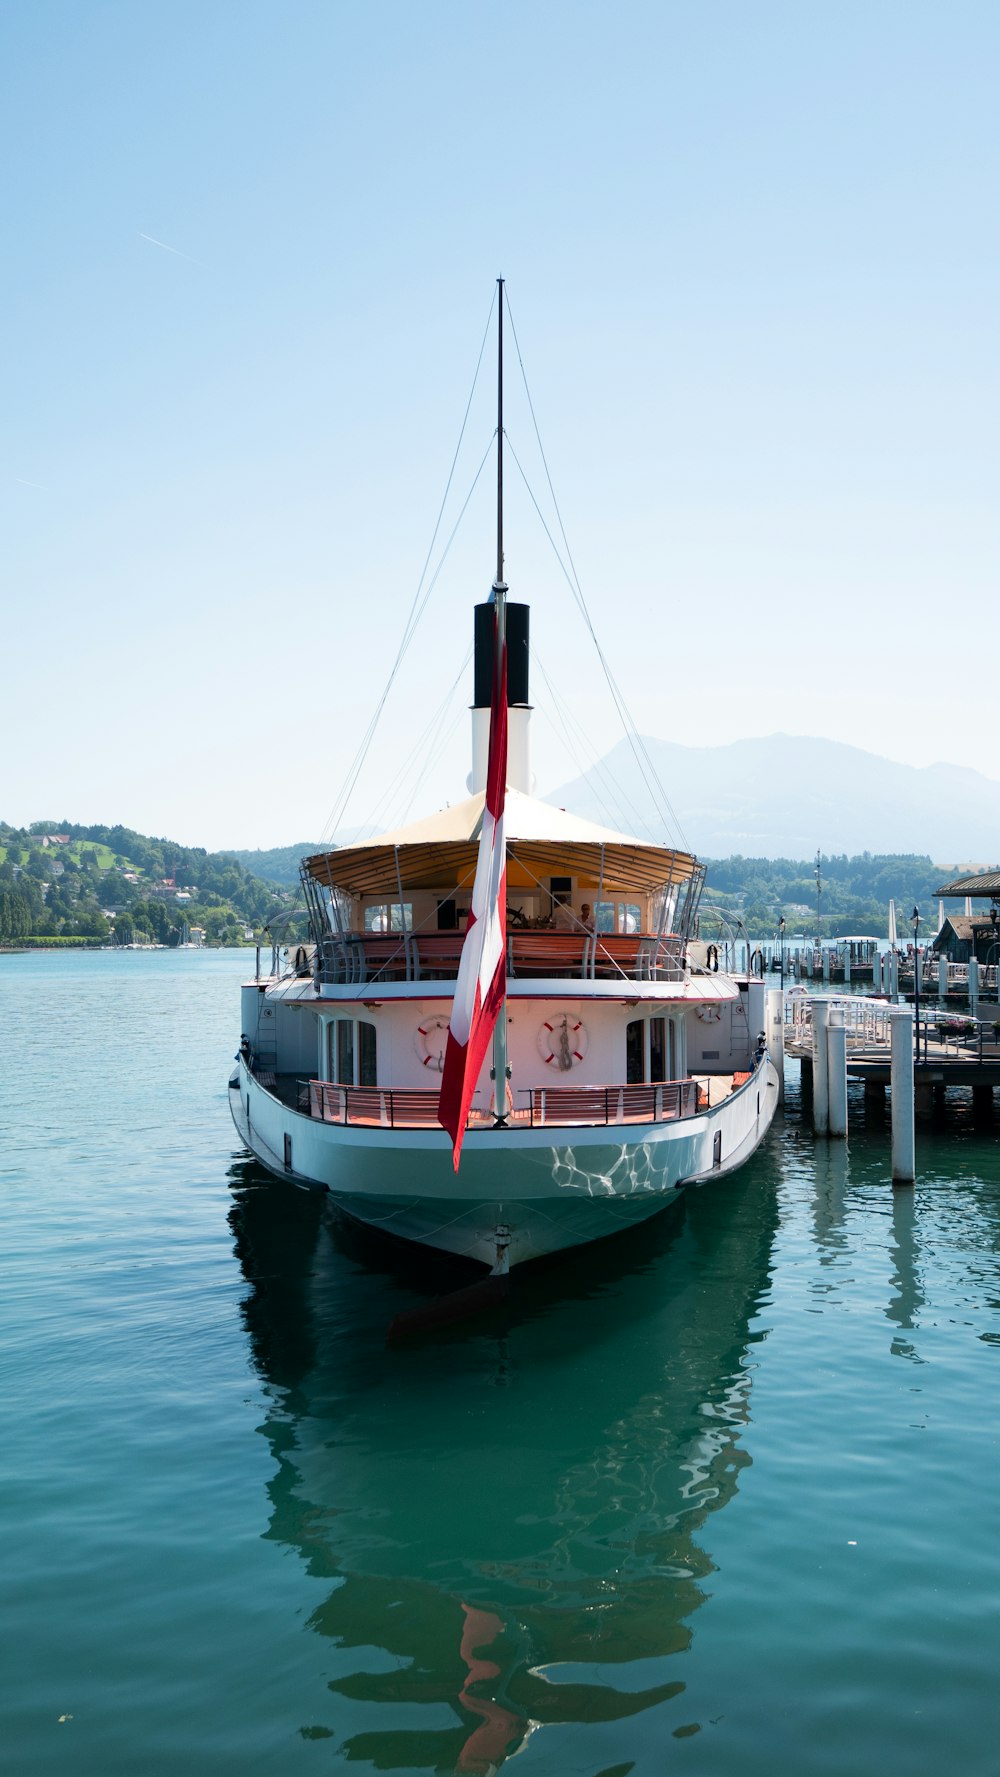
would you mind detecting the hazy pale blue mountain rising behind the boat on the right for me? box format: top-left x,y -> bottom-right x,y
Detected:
545,734 -> 1000,865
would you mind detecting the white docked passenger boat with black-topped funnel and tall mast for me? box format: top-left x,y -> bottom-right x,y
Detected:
229,293 -> 782,1274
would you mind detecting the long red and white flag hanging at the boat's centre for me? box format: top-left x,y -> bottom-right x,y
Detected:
437,615 -> 506,1171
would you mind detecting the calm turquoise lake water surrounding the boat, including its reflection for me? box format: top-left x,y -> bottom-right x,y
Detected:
0,952 -> 1000,1777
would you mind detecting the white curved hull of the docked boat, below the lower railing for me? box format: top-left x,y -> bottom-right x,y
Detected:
229,1059 -> 778,1267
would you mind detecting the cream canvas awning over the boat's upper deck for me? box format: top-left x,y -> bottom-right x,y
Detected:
306,791 -> 702,897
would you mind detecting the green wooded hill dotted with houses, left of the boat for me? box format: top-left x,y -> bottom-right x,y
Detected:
0,821 -> 298,944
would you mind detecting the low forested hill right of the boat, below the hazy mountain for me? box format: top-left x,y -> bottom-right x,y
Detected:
703,851 -> 961,938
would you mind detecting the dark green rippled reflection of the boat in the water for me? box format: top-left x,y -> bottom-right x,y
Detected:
233,1159 -> 774,1772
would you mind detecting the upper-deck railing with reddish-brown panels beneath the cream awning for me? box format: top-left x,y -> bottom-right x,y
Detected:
321,929 -> 684,986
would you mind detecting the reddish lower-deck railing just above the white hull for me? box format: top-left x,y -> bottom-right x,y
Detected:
309,1075 -> 706,1128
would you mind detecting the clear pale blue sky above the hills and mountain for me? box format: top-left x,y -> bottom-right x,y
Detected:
0,0 -> 1000,848
